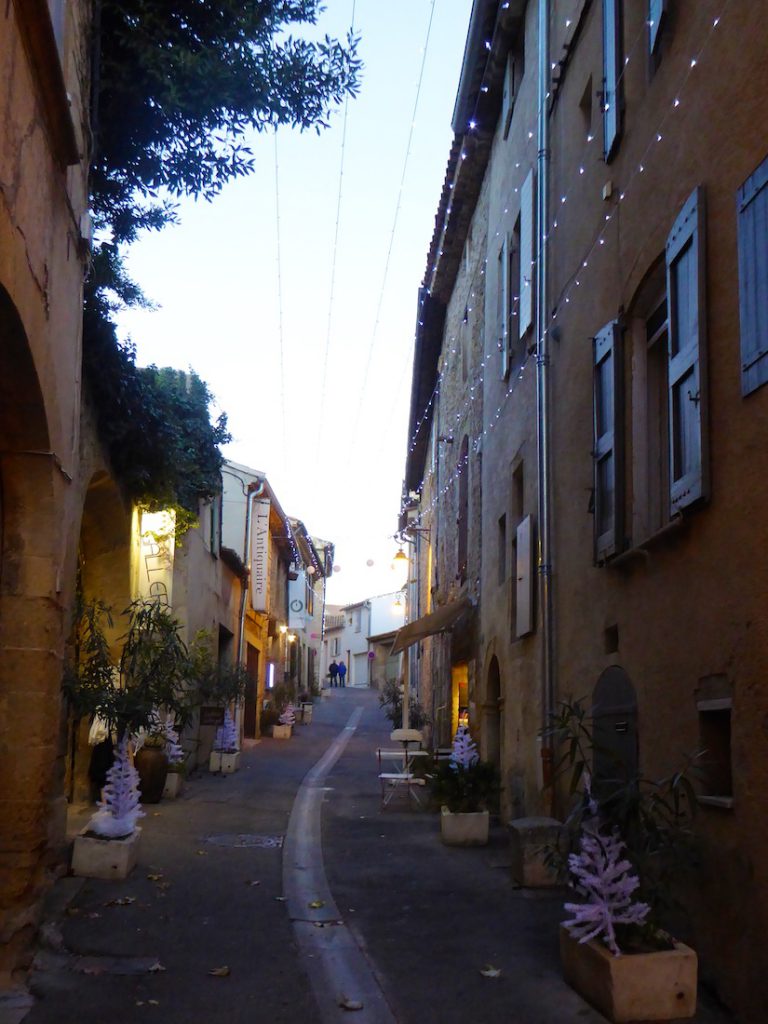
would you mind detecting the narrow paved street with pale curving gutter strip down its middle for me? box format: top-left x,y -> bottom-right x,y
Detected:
25,688 -> 730,1024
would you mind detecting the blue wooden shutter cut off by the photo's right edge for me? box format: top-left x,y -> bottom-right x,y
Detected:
736,160 -> 768,395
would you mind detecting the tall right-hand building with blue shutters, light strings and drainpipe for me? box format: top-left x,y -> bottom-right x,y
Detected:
400,0 -> 768,1021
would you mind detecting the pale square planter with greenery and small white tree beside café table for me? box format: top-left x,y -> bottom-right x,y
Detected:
431,726 -> 499,846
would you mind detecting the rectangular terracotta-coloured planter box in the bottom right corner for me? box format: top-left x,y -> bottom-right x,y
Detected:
560,926 -> 697,1024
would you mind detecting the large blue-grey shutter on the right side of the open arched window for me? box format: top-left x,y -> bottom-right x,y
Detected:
667,188 -> 708,514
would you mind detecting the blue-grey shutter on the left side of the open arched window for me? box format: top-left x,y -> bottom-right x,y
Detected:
593,321 -> 624,562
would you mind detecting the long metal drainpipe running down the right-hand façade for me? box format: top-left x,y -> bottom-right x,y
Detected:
536,0 -> 555,787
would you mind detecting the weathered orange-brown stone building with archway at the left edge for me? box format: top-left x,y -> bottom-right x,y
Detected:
0,0 -> 94,983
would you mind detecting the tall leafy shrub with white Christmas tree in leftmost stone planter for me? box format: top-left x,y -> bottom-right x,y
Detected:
65,601 -> 195,878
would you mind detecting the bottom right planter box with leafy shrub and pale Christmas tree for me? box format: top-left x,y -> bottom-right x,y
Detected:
548,700 -> 697,1022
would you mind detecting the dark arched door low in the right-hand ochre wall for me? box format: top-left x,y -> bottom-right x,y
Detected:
592,665 -> 639,793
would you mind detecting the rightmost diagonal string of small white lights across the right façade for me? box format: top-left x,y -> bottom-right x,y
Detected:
405,0 -> 731,523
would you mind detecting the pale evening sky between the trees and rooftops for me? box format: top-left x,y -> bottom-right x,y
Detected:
120,0 -> 472,603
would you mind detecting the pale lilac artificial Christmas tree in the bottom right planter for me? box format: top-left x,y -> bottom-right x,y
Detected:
564,821 -> 650,956
